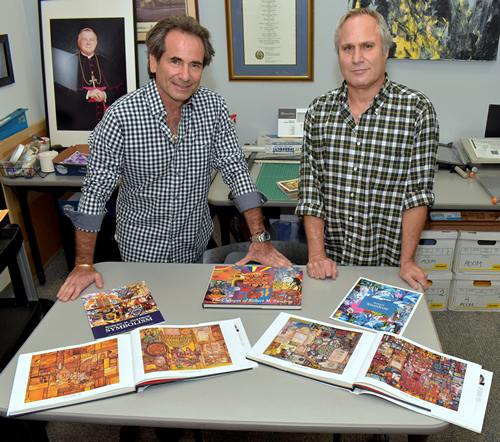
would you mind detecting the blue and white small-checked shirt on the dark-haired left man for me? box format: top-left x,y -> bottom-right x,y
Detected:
69,80 -> 266,263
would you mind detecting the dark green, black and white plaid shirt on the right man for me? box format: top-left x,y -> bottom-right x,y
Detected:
296,77 -> 439,266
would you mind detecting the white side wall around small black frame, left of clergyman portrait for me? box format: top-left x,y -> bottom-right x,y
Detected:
0,0 -> 45,125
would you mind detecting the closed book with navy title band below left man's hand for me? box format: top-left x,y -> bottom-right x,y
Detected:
82,281 -> 164,339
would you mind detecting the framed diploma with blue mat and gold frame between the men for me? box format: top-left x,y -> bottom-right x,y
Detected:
225,0 -> 314,81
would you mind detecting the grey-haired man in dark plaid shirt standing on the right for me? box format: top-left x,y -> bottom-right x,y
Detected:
296,8 -> 439,290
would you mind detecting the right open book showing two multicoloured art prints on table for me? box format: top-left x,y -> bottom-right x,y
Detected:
247,312 -> 492,432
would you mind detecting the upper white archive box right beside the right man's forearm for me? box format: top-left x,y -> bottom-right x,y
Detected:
415,230 -> 458,273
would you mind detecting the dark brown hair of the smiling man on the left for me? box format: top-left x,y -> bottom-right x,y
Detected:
146,15 -> 215,78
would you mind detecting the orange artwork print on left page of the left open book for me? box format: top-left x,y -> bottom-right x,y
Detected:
24,339 -> 120,403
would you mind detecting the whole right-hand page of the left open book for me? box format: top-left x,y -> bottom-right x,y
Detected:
130,319 -> 255,386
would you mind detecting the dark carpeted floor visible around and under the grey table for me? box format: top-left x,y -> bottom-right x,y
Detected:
19,252 -> 500,442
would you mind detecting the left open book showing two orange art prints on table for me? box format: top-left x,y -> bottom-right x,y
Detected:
7,318 -> 257,416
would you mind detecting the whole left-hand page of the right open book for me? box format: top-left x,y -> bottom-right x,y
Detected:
247,312 -> 376,388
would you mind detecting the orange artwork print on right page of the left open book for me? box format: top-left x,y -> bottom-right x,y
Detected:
140,325 -> 232,373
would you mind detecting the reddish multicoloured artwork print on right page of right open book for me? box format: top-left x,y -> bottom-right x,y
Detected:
366,334 -> 467,411
